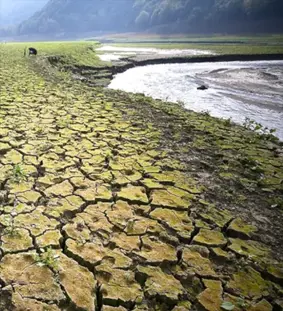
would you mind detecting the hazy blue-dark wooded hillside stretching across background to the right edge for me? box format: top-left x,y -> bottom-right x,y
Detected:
18,0 -> 283,34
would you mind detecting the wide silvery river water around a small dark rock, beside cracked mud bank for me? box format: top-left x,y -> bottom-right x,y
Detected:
109,61 -> 283,140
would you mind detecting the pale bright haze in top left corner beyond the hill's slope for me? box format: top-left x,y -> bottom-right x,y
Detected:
0,0 -> 48,26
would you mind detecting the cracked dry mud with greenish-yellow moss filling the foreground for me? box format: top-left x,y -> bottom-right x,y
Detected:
0,45 -> 283,311
